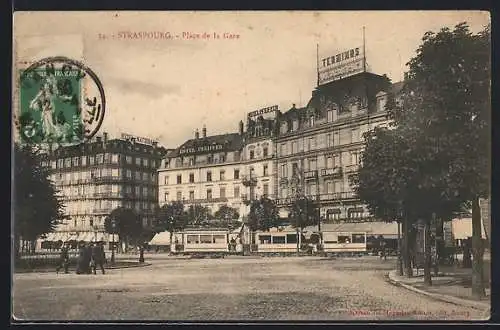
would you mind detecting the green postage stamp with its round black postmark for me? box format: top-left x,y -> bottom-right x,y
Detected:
16,56 -> 106,145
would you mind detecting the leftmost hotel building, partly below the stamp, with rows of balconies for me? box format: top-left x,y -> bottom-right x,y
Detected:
38,133 -> 167,248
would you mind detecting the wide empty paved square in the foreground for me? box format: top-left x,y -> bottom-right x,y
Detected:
13,257 -> 489,321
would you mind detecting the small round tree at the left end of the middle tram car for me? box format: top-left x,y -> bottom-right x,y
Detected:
247,196 -> 280,236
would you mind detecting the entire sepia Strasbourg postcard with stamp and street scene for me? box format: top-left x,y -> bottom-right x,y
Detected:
11,11 -> 491,323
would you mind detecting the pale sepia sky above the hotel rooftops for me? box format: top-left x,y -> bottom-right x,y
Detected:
13,11 -> 490,148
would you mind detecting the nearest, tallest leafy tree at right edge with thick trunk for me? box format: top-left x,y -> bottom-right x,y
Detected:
391,23 -> 491,297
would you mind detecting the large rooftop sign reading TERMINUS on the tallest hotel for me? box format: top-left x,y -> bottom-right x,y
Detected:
318,47 -> 365,85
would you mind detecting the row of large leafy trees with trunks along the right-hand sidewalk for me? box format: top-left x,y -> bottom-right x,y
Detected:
352,23 -> 491,297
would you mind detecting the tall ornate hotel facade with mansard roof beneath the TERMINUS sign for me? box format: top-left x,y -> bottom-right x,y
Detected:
275,72 -> 402,223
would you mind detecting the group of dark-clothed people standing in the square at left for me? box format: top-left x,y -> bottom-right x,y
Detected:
56,242 -> 106,274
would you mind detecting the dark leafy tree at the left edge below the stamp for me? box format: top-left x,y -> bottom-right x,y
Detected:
14,143 -> 65,256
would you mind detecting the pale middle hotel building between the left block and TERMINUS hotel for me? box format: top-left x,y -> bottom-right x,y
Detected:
158,111 -> 275,220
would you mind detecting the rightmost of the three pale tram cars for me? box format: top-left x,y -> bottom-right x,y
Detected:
321,231 -> 367,255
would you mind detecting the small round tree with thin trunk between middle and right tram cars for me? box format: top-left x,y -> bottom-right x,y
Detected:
288,195 -> 319,254
